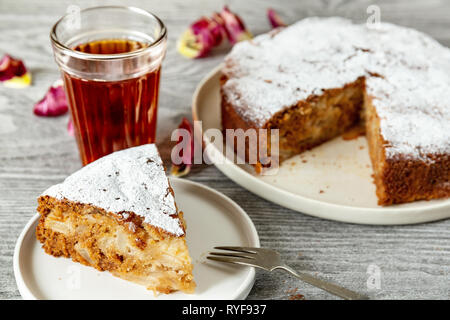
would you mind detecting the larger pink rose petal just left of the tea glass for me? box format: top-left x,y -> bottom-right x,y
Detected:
33,79 -> 69,117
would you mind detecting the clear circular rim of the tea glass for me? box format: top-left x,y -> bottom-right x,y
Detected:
50,6 -> 167,60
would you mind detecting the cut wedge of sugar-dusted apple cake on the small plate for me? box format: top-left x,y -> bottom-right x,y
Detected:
36,144 -> 195,293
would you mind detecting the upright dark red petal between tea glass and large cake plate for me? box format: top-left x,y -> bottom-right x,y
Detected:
170,118 -> 194,177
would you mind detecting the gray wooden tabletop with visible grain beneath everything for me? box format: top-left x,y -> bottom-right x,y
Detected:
0,0 -> 450,299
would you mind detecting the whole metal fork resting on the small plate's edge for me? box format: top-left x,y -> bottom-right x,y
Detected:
206,247 -> 369,300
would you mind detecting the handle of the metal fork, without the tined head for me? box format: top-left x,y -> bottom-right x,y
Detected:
275,265 -> 369,300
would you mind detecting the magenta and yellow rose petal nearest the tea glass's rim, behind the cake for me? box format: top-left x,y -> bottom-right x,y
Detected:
177,17 -> 225,58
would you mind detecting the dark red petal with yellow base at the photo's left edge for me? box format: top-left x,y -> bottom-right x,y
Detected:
0,54 -> 31,88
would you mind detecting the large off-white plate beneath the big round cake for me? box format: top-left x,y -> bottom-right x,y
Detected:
192,66 -> 450,225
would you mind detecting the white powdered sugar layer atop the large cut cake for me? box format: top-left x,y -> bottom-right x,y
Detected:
223,18 -> 450,161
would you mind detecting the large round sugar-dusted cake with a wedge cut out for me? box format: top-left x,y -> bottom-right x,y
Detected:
221,17 -> 450,205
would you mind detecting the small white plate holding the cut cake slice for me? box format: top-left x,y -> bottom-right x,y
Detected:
14,178 -> 259,300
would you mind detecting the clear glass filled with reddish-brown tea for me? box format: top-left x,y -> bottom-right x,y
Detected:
50,6 -> 167,165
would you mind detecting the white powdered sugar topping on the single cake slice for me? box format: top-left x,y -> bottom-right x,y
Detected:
43,144 -> 184,236
